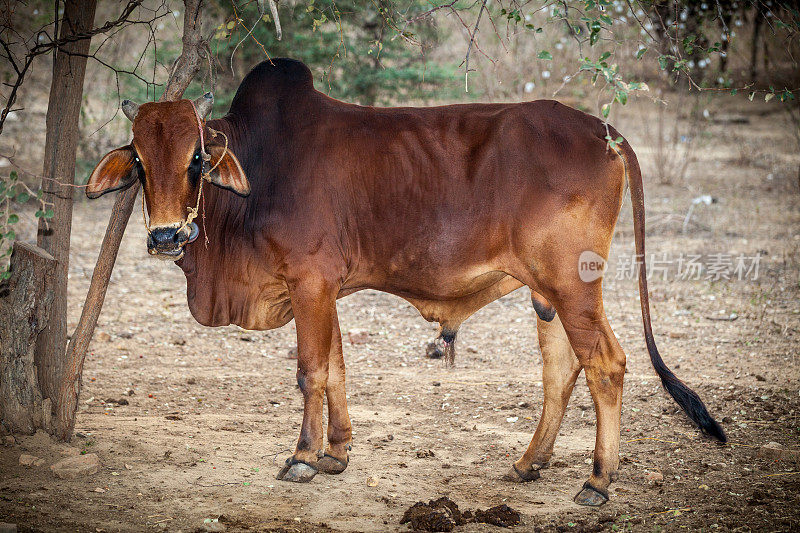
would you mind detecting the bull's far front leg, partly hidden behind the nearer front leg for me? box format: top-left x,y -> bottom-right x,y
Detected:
317,313 -> 352,474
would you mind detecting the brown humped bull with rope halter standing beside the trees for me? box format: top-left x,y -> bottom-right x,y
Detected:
86,59 -> 725,505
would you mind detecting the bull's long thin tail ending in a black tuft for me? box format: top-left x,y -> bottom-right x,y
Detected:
614,141 -> 728,442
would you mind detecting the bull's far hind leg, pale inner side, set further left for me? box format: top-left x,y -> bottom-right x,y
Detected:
504,313 -> 581,482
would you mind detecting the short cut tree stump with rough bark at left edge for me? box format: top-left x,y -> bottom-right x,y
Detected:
0,241 -> 56,434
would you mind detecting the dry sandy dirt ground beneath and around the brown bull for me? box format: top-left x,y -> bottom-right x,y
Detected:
0,99 -> 800,532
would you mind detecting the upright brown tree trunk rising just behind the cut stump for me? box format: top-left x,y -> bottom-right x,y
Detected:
34,0 -> 97,412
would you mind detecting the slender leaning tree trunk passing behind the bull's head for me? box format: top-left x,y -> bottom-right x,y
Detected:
55,0 -> 205,440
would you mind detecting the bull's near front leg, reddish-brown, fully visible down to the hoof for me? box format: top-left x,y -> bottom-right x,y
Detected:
277,279 -> 338,482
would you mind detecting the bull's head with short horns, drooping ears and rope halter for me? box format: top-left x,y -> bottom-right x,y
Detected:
86,93 -> 250,260
